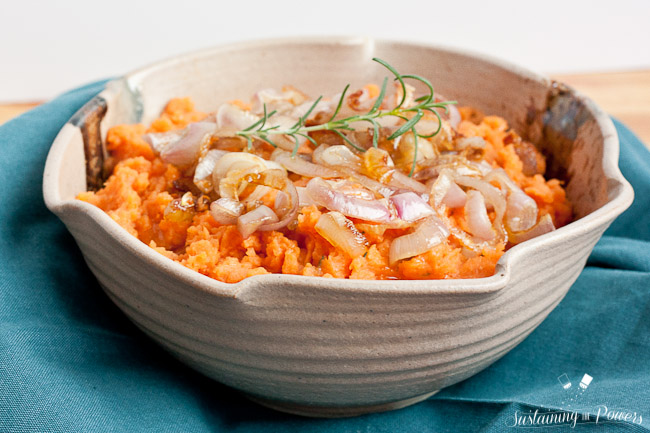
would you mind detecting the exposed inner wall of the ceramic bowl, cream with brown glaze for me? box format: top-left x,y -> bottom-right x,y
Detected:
69,39 -> 608,218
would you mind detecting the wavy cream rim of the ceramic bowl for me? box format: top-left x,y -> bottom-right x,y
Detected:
43,36 -> 634,297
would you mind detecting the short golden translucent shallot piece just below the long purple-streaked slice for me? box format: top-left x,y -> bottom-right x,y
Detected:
314,212 -> 368,258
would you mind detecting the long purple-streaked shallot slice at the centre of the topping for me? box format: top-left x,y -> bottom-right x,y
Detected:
307,177 -> 391,223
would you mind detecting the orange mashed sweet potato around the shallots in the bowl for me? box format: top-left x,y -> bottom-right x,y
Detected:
78,99 -> 572,283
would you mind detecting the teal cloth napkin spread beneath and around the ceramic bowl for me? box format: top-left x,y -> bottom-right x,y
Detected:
0,82 -> 650,433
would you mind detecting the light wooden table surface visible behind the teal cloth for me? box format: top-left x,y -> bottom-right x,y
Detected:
0,70 -> 650,147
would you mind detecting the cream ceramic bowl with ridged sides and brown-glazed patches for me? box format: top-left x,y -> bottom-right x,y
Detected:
43,38 -> 633,416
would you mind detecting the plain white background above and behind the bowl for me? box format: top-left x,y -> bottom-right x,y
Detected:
0,0 -> 650,102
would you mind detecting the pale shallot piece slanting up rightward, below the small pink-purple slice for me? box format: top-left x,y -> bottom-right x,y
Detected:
388,217 -> 449,265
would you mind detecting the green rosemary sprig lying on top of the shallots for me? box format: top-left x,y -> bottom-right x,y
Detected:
236,57 -> 456,176
